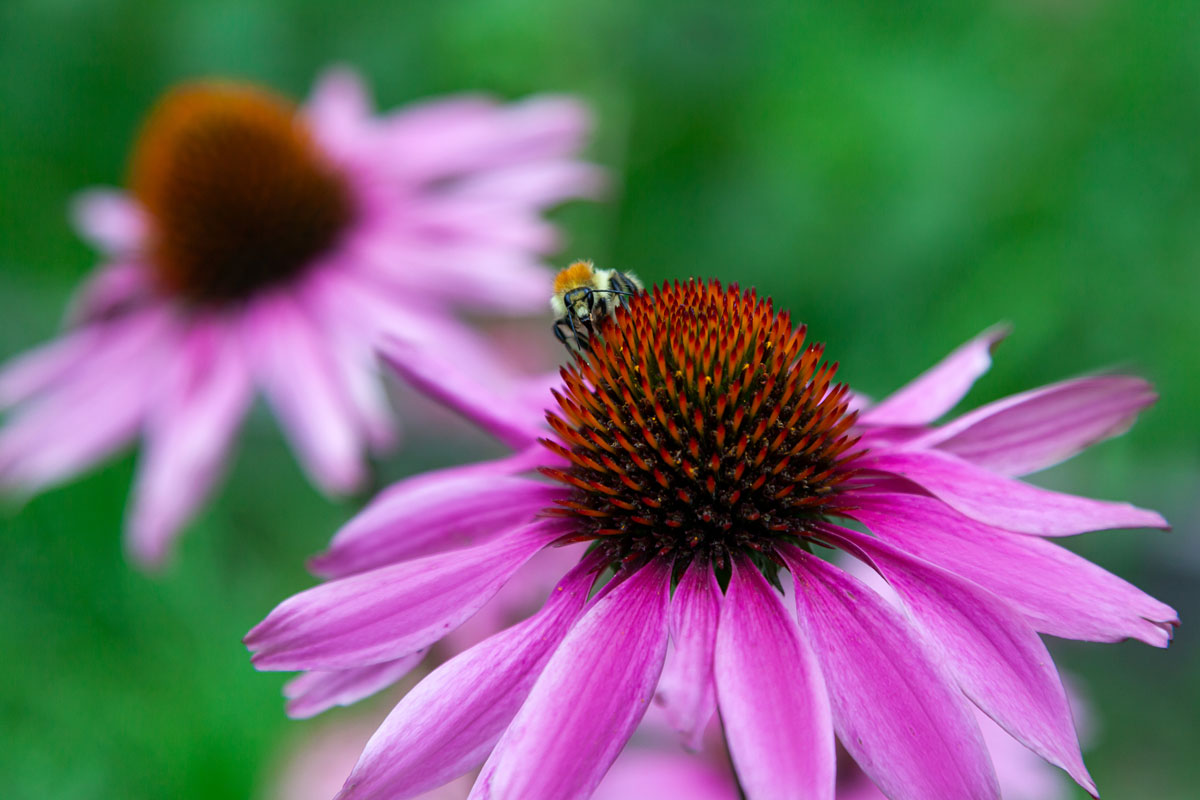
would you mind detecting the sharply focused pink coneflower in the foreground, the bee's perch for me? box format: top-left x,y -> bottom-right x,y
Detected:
246,282 -> 1177,800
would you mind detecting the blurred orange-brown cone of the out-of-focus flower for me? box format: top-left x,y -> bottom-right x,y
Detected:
130,83 -> 354,305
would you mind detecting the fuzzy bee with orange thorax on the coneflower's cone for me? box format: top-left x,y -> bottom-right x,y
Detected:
550,261 -> 642,351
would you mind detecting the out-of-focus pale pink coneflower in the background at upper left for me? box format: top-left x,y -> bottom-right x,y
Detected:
0,70 -> 600,565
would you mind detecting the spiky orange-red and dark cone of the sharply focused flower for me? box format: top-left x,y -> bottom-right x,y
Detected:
542,281 -> 858,567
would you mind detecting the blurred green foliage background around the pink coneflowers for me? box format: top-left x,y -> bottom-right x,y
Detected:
0,0 -> 1200,800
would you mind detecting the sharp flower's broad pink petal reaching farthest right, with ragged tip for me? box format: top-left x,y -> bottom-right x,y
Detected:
848,493 -> 1178,646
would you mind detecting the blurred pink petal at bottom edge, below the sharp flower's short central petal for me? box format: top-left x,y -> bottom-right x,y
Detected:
592,747 -> 738,800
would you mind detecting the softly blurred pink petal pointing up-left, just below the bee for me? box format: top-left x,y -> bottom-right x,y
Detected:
382,328 -> 546,450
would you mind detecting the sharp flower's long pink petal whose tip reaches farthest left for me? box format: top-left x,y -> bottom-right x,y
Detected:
244,521 -> 564,670
